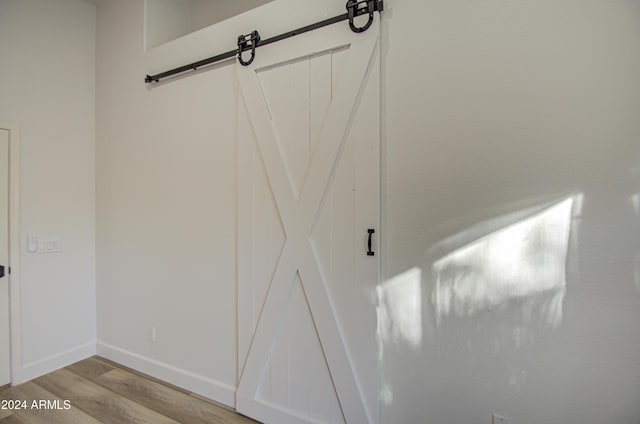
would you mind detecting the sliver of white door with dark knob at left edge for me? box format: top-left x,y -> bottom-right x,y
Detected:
0,128 -> 11,386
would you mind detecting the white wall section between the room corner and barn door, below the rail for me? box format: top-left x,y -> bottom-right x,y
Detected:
96,0 -> 236,404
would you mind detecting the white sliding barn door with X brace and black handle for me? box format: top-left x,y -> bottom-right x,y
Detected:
236,17 -> 380,424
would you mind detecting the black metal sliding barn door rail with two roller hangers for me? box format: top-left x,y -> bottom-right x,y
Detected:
144,0 -> 384,84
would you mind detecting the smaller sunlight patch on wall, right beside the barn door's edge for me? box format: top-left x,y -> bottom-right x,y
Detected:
378,267 -> 422,350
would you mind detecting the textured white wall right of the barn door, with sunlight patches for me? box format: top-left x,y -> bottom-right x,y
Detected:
381,0 -> 640,424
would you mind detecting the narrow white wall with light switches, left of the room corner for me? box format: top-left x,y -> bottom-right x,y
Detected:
0,0 -> 96,383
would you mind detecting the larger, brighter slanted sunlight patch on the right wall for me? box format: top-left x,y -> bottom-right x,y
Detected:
431,197 -> 574,327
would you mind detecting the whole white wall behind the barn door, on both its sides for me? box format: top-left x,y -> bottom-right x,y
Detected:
97,0 -> 640,424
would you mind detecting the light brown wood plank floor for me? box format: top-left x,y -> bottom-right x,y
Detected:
0,356 -> 256,424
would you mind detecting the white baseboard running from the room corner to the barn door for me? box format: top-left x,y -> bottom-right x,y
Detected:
97,342 -> 235,408
